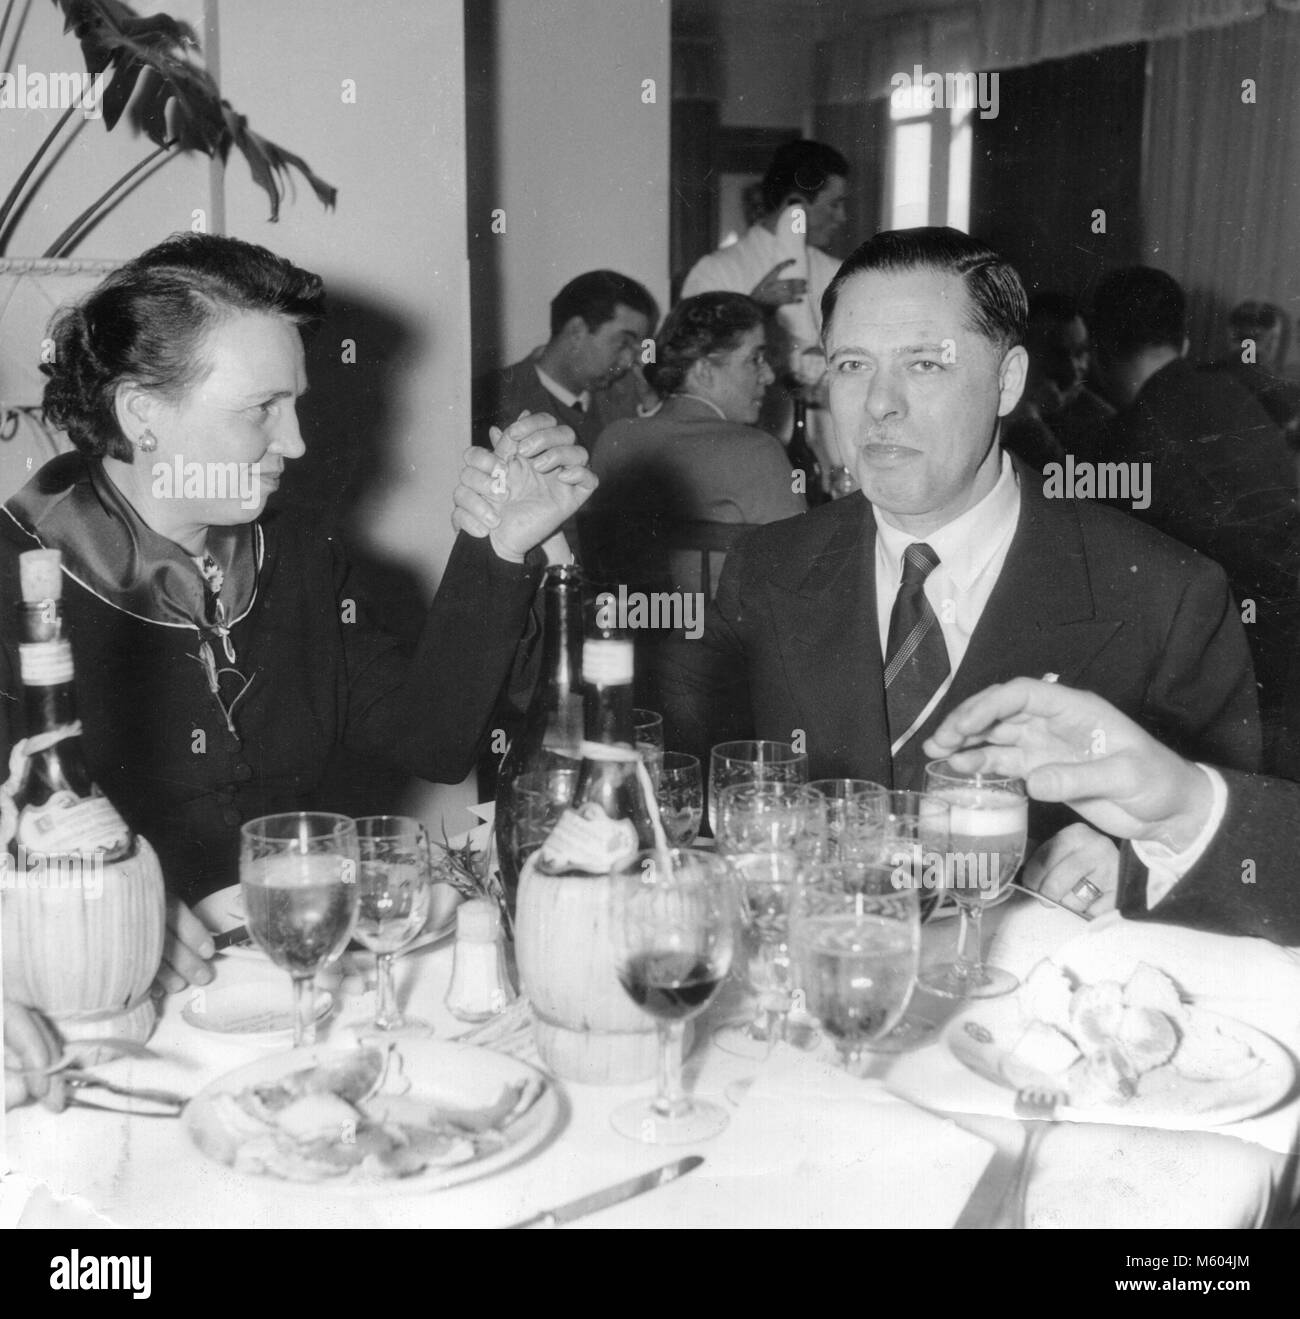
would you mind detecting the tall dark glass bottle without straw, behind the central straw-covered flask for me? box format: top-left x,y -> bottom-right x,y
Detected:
494,565 -> 583,913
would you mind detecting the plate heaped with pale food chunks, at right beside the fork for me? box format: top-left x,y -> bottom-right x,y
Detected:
944,960 -> 1296,1130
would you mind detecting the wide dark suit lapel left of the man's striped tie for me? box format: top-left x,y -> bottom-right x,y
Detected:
759,495 -> 891,783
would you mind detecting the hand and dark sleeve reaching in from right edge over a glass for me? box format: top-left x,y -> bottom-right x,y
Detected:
926,678 -> 1300,944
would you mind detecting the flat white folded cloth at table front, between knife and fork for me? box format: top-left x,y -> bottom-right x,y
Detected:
592,1046 -> 993,1228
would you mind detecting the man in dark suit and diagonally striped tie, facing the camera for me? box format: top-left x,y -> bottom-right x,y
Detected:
665,228 -> 1259,896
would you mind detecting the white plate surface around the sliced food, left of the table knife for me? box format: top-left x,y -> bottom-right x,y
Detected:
185,1039 -> 567,1198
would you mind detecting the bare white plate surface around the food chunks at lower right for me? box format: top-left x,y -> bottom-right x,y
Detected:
944,995 -> 1296,1132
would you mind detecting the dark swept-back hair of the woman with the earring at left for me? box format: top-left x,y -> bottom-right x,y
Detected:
41,233 -> 324,462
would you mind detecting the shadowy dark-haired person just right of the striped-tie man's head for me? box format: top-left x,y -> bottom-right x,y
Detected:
1002,293 -> 1114,471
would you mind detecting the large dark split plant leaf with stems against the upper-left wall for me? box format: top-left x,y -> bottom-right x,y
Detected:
0,0 -> 338,256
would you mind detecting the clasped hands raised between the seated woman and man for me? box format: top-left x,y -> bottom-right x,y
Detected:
451,413 -> 597,563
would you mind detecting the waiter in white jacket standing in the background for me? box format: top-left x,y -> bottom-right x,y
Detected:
682,140 -> 849,488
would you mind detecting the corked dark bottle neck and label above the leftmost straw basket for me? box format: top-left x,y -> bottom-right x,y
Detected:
4,550 -> 133,868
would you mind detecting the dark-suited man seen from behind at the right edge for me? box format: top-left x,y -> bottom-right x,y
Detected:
1093,266 -> 1300,777
